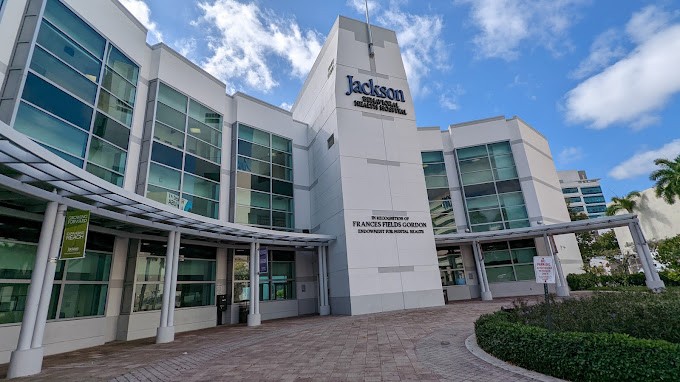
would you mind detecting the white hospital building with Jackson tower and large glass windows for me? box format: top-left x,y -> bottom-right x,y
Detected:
0,0 -> 581,375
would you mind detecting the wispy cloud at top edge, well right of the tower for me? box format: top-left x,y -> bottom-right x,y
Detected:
458,0 -> 582,60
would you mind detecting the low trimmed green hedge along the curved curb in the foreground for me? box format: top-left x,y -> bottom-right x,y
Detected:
475,312 -> 680,382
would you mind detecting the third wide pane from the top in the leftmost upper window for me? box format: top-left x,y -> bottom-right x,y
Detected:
31,46 -> 97,103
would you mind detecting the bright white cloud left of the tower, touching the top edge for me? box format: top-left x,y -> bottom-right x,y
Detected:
194,0 -> 322,92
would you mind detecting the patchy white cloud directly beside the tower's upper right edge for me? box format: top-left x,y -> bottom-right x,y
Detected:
375,1 -> 449,97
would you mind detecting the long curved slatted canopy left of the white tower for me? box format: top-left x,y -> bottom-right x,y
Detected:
0,122 -> 335,247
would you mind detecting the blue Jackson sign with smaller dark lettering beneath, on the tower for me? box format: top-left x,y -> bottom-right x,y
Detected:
345,75 -> 406,115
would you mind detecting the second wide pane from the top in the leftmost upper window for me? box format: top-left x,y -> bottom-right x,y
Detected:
38,22 -> 101,82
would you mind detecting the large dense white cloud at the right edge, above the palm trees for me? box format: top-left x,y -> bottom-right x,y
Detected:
565,24 -> 680,129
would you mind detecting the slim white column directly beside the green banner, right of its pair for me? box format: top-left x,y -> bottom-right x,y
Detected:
31,204 -> 66,349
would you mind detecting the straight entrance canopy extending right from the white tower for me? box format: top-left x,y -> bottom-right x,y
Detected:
435,214 -> 638,245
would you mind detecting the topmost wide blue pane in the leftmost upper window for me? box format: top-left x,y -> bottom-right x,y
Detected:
45,0 -> 106,58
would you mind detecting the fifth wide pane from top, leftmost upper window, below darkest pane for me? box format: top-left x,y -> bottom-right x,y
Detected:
14,102 -> 87,160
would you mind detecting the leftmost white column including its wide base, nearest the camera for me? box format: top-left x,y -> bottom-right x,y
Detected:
7,202 -> 58,378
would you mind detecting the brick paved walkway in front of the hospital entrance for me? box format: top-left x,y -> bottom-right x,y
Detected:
0,299 -> 552,381
